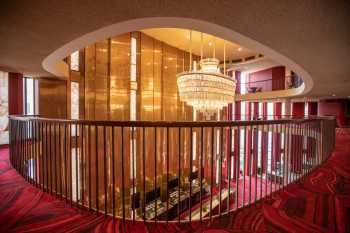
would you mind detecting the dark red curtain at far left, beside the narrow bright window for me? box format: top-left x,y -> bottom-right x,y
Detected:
8,73 -> 23,115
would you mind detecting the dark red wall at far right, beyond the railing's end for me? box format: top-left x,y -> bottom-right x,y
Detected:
318,100 -> 350,127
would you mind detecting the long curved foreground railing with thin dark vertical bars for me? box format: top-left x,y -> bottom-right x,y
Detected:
10,116 -> 335,222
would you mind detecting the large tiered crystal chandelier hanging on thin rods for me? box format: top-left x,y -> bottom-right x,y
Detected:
177,31 -> 236,119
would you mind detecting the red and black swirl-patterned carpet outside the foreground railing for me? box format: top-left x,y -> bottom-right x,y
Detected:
0,129 -> 350,233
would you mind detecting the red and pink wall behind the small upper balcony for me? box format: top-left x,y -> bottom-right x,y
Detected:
246,66 -> 285,91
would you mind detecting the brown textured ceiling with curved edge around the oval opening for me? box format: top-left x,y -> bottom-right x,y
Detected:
0,0 -> 350,97
